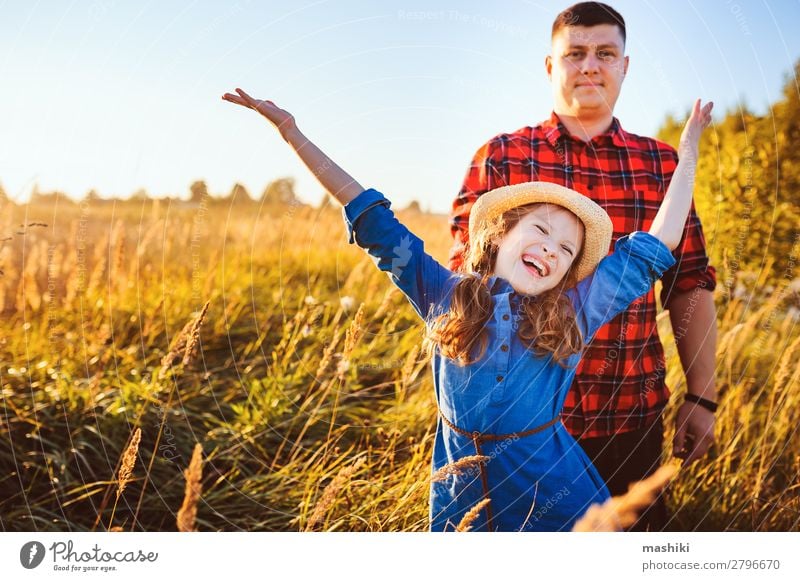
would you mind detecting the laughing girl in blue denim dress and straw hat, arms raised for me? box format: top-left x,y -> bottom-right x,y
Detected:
222,89 -> 712,531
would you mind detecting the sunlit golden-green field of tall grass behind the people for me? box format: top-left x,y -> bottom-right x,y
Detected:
0,202 -> 800,531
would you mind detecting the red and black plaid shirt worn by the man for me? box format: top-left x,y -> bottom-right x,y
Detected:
449,113 -> 716,438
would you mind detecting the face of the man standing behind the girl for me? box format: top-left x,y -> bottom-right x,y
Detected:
545,24 -> 628,118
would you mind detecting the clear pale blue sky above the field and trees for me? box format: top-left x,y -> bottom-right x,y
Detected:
0,0 -> 800,212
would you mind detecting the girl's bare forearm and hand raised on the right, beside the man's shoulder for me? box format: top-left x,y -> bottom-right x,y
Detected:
650,99 -> 714,250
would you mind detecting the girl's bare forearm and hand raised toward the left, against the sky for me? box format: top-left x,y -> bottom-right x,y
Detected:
222,89 -> 364,206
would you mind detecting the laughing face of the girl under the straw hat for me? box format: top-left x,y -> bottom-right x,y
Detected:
494,204 -> 583,296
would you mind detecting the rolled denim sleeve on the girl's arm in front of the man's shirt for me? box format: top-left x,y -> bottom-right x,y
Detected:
566,232 -> 675,343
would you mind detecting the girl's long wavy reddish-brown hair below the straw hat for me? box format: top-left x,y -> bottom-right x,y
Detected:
424,204 -> 585,367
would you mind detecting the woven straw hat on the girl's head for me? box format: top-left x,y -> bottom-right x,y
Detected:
469,182 -> 613,280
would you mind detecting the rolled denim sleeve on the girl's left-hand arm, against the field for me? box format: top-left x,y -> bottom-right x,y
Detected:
342,189 -> 457,320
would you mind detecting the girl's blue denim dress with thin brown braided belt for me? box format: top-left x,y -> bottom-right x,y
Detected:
343,189 -> 675,531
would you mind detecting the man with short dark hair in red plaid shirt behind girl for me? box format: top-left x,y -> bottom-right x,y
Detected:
450,2 -> 717,530
